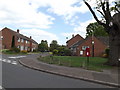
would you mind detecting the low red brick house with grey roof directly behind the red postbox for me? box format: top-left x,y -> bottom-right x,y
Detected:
66,36 -> 109,57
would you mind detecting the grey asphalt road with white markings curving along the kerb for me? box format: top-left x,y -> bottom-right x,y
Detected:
0,55 -> 111,88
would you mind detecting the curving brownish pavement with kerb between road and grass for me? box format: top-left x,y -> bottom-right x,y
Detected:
19,55 -> 120,88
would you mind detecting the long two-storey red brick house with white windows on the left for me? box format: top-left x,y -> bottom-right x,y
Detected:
0,27 -> 38,51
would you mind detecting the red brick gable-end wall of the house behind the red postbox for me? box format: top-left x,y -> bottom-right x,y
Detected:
76,37 -> 107,56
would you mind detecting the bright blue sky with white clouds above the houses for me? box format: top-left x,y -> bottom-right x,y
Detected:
0,0 -> 114,45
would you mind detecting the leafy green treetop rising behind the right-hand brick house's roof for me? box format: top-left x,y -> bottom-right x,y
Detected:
86,22 -> 108,37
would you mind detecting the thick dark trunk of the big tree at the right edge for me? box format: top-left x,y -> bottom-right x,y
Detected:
107,13 -> 120,66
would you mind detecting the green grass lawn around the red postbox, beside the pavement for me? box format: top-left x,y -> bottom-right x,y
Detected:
38,56 -> 112,71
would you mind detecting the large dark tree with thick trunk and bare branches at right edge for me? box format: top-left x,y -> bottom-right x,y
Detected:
84,0 -> 120,66
